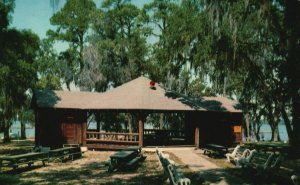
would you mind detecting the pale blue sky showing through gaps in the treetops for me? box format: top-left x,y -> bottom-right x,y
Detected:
11,0 -> 149,51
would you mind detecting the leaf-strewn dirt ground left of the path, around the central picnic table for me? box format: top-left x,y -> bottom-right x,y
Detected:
0,151 -> 169,185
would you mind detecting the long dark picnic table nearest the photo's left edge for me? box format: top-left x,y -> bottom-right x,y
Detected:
0,152 -> 49,169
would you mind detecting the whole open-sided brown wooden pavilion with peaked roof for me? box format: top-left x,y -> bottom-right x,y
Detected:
32,76 -> 242,149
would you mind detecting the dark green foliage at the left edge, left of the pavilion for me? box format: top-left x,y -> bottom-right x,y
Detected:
1,30 -> 39,106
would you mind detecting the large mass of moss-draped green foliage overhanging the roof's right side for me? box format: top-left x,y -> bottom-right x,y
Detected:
144,0 -> 300,143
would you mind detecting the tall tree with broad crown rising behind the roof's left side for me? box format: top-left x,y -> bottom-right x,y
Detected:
47,0 -> 96,88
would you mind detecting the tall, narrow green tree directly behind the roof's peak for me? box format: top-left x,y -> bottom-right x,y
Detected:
143,0 -> 179,83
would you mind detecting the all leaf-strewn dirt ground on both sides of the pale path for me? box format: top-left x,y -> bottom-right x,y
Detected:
0,141 -> 299,185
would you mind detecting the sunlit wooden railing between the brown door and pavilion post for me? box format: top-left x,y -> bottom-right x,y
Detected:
86,131 -> 139,144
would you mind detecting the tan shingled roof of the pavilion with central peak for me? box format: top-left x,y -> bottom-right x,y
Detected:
34,76 -> 241,112
